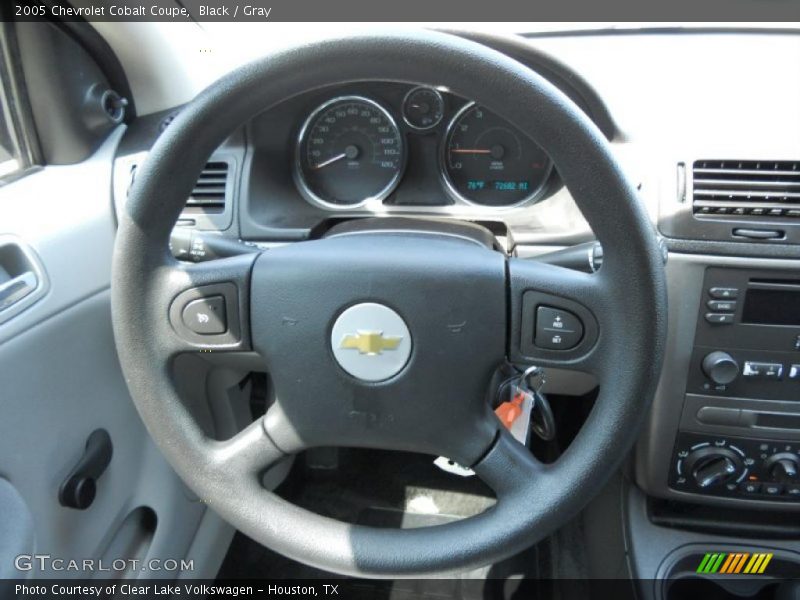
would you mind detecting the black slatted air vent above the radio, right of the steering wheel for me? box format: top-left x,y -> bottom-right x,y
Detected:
692,160 -> 800,223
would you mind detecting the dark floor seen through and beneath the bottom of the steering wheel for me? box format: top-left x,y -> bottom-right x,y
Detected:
218,450 -> 553,600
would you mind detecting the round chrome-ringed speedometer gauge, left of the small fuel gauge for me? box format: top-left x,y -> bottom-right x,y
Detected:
295,96 -> 404,208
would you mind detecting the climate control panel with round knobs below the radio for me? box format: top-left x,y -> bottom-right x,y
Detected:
669,432 -> 800,502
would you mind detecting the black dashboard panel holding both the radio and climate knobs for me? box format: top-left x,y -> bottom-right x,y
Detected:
669,267 -> 800,502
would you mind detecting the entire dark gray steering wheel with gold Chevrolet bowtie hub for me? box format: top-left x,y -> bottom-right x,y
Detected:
112,31 -> 666,577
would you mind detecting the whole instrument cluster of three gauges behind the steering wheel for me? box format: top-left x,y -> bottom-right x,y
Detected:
293,87 -> 553,210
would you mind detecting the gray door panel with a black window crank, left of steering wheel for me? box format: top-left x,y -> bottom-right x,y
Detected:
0,127 -> 232,577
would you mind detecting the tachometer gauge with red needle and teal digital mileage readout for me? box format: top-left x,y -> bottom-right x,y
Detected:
443,104 -> 552,206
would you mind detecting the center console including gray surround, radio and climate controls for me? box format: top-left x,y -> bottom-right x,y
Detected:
637,256 -> 800,510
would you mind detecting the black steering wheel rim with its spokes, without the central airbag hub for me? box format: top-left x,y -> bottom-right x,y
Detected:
112,31 -> 666,576
